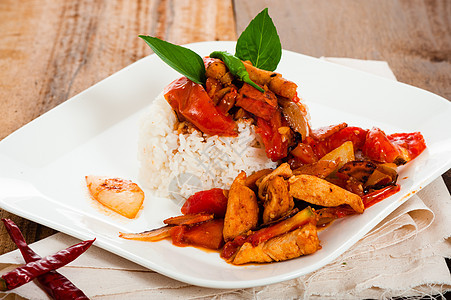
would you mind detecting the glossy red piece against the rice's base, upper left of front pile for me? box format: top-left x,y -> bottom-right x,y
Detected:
181,188 -> 227,218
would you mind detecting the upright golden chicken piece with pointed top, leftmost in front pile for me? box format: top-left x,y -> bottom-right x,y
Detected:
223,172 -> 258,241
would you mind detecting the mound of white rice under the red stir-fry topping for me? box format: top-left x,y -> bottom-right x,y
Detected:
138,94 -> 277,200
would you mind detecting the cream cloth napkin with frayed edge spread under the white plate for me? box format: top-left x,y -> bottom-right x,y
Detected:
0,58 -> 451,299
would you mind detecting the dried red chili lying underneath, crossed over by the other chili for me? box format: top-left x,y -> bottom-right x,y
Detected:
2,219 -> 89,300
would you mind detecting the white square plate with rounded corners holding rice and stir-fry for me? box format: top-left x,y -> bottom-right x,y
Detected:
0,42 -> 451,288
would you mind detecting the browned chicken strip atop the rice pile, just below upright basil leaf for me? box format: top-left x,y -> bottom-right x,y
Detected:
243,61 -> 297,99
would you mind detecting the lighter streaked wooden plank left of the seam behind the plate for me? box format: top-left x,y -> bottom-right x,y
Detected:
0,0 -> 236,254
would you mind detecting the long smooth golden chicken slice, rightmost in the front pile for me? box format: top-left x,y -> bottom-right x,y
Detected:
288,175 -> 365,213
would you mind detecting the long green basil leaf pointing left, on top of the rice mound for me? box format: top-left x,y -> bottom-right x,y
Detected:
139,35 -> 206,84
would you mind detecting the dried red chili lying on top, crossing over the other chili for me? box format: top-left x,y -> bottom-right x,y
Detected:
0,232 -> 95,291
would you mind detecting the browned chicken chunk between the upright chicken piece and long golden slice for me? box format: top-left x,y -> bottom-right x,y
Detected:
263,176 -> 294,224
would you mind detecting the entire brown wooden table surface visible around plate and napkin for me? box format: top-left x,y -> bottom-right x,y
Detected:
0,0 -> 451,290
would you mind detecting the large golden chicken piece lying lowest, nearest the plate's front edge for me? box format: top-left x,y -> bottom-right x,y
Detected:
232,223 -> 321,265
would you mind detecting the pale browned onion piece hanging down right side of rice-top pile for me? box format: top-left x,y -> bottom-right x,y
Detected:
278,97 -> 310,140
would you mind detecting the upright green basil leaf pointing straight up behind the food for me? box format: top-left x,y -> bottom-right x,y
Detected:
235,8 -> 282,71
